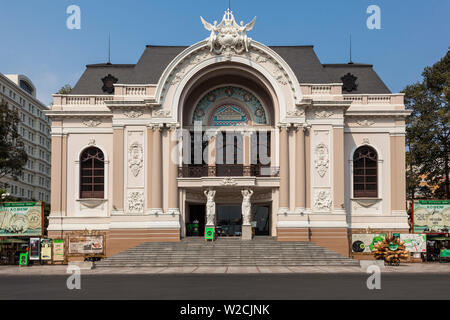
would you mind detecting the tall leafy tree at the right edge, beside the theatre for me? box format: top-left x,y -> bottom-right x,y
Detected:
404,52 -> 450,199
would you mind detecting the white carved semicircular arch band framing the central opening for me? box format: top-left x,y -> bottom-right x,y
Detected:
155,41 -> 302,123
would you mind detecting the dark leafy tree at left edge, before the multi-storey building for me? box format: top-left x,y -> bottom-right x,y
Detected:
0,101 -> 28,182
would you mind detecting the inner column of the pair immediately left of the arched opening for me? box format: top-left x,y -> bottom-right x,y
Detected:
167,124 -> 180,213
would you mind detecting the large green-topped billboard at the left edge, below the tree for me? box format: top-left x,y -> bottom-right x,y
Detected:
0,202 -> 44,237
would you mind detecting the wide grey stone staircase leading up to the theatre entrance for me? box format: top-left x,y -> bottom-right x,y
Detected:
96,237 -> 359,267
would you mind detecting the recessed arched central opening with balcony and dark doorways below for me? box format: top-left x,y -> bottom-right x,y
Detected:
179,65 -> 279,236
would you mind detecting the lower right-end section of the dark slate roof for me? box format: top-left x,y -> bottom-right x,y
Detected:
323,63 -> 391,94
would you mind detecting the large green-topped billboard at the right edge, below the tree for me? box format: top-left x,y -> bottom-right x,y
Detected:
413,200 -> 450,234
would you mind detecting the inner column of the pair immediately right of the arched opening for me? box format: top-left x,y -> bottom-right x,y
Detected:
278,124 -> 289,212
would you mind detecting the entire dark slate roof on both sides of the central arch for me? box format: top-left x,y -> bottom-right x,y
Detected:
72,46 -> 390,94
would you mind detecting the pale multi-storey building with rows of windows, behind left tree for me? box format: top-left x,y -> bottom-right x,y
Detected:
0,73 -> 51,202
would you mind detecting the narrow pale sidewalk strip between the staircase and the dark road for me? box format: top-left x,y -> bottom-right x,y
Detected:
0,263 -> 450,276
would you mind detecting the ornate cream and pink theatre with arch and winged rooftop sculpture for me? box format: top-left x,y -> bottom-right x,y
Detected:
47,11 -> 409,255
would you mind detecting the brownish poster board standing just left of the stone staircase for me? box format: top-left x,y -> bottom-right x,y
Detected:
65,231 -> 106,258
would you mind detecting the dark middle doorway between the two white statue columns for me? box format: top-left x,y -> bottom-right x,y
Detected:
216,205 -> 242,237
